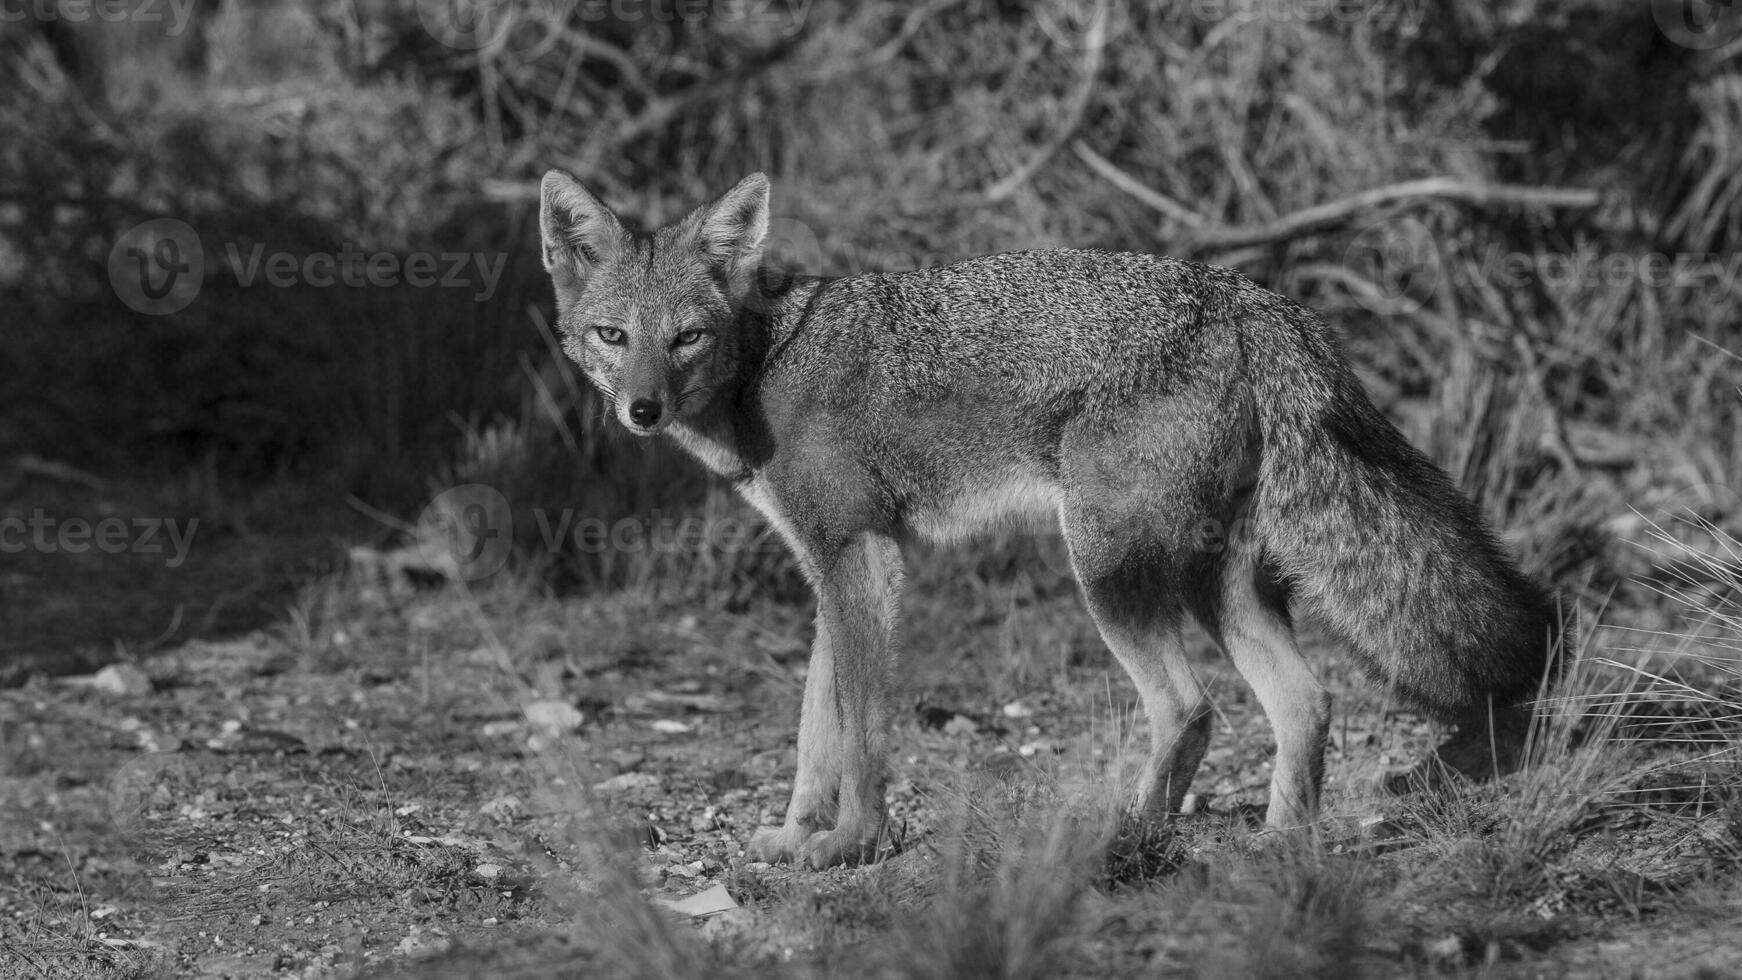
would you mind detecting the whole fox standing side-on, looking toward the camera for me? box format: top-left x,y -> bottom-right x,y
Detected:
538,169 -> 1559,869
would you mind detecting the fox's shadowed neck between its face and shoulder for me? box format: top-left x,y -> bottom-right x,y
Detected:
667,277 -> 822,482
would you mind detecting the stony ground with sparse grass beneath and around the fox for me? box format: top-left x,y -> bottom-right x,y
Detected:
0,518 -> 1742,977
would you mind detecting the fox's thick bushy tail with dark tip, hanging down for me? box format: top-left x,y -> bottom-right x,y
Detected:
1254,305 -> 1561,721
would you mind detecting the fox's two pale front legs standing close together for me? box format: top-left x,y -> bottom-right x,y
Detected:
749,536 -> 901,869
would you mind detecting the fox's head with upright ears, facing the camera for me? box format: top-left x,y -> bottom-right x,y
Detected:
538,171 -> 768,435
